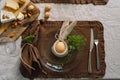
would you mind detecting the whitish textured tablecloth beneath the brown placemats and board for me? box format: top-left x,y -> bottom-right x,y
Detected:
0,0 -> 120,80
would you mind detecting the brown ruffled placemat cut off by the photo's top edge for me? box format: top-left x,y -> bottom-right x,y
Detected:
31,0 -> 108,5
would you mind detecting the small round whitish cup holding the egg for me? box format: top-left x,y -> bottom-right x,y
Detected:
52,40 -> 68,57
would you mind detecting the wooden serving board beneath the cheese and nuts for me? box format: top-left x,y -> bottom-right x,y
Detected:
0,2 -> 40,42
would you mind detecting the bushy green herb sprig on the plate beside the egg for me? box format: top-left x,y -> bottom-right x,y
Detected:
57,35 -> 85,67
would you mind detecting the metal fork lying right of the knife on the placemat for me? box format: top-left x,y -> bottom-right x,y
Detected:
94,32 -> 100,70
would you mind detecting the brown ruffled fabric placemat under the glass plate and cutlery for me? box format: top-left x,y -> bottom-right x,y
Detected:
20,21 -> 106,79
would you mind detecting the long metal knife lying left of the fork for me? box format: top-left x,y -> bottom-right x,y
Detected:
88,28 -> 94,73
